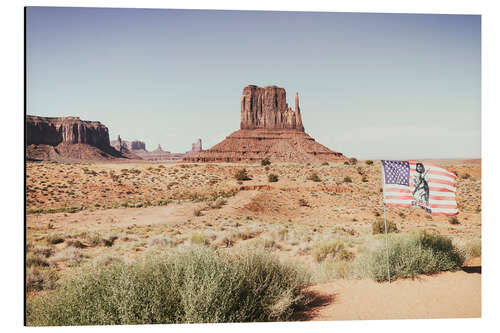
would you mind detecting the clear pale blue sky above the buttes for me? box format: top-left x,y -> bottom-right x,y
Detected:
26,7 -> 481,159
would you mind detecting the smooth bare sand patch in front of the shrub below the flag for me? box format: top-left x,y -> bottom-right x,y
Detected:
302,272 -> 481,321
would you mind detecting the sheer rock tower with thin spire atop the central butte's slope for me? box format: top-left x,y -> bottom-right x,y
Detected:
240,85 -> 304,132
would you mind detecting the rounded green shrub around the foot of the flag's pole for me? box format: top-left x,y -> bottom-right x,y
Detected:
357,231 -> 464,282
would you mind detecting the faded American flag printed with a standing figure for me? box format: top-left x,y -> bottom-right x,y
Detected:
382,160 -> 458,216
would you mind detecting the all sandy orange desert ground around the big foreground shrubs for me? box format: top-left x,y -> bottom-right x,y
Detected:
26,161 -> 481,320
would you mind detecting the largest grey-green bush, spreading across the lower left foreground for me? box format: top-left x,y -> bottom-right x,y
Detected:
27,247 -> 309,326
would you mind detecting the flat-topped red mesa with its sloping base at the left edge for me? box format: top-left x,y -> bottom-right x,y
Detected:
26,115 -> 127,161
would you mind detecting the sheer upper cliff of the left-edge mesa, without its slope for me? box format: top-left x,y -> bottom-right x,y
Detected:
26,116 -> 110,148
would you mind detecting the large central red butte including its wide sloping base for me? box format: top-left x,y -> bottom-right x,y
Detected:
184,85 -> 346,163
